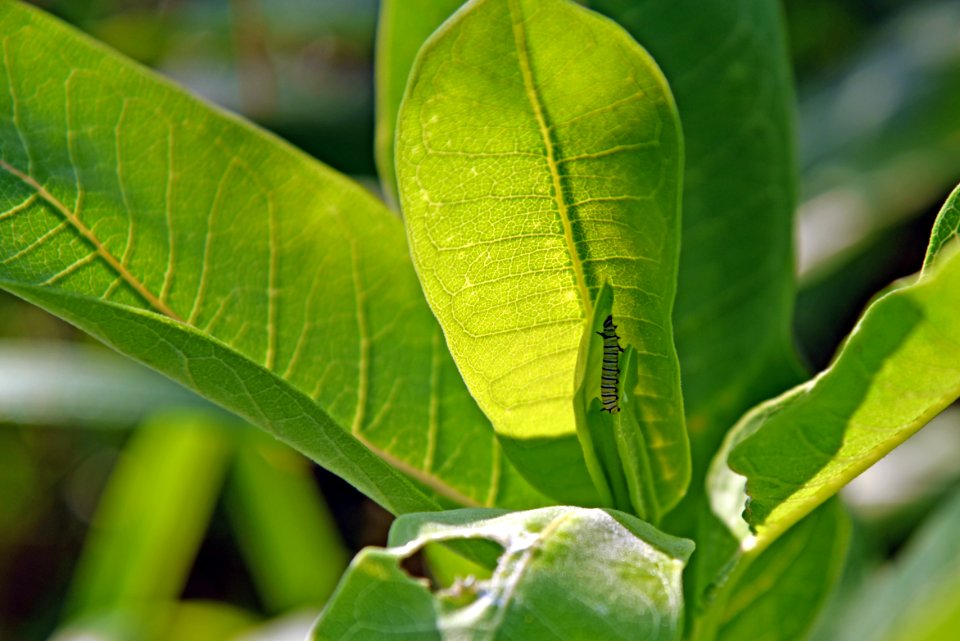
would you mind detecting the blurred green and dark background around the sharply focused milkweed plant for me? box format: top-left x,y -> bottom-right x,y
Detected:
0,0 -> 960,641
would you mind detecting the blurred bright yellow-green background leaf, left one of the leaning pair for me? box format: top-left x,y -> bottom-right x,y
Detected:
67,413 -> 233,619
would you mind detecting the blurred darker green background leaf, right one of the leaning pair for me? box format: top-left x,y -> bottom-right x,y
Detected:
228,430 -> 349,612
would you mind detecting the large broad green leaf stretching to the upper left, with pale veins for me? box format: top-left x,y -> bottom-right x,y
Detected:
0,1 -> 542,512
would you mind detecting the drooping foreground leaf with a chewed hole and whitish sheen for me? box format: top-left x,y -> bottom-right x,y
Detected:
313,507 -> 692,641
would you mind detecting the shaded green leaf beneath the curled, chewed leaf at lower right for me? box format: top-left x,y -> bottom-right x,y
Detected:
708,500 -> 851,641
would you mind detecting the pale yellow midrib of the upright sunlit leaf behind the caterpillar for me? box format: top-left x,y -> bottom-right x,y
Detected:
508,0 -> 593,318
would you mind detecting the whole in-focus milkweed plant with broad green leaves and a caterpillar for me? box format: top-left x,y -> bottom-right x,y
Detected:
0,0 -> 960,641
